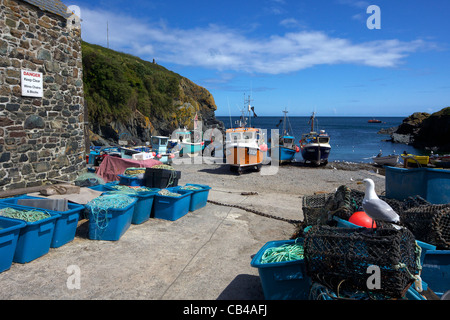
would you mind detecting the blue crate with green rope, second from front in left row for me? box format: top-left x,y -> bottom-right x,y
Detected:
0,203 -> 60,263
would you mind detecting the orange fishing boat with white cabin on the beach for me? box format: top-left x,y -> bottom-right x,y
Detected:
225,98 -> 267,174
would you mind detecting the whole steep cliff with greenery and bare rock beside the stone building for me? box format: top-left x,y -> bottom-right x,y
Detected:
82,42 -> 224,145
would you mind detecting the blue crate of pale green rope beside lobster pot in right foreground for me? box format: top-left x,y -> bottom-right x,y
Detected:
250,239 -> 311,300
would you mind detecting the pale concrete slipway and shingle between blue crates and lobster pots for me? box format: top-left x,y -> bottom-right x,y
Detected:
0,165 -> 384,300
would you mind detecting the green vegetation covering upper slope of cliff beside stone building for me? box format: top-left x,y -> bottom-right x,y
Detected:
82,42 -> 182,125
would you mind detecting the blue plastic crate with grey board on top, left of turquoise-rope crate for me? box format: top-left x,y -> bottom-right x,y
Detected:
2,195 -> 84,248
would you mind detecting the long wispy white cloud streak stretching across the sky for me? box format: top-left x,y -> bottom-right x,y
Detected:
82,9 -> 425,74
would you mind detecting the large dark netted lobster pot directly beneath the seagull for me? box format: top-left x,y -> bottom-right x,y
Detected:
304,225 -> 420,299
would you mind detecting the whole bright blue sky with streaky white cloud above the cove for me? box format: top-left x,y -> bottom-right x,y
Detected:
64,0 -> 450,117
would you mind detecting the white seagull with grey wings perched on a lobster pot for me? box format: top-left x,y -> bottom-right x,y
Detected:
358,179 -> 400,223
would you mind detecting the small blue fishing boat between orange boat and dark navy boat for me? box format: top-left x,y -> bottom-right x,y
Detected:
271,110 -> 300,163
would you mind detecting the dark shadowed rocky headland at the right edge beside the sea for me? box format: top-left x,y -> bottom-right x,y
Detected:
391,107 -> 450,153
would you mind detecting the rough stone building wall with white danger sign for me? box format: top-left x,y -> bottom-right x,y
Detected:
0,0 -> 86,190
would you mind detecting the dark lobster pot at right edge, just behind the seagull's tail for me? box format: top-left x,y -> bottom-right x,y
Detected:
400,204 -> 450,250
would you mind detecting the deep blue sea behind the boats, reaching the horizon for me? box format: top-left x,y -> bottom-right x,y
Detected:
216,116 -> 423,162
